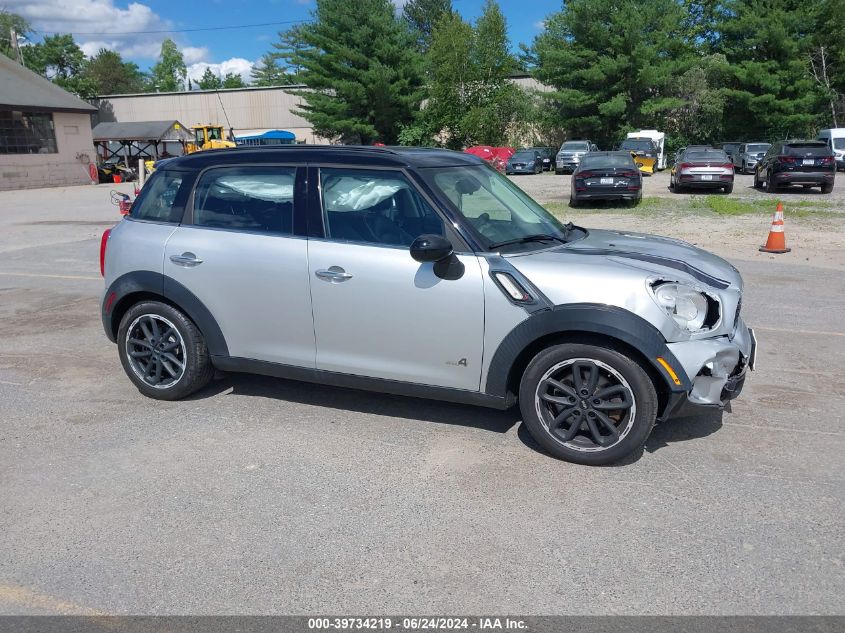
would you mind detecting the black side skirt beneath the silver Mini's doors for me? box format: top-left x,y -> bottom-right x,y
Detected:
211,356 -> 516,410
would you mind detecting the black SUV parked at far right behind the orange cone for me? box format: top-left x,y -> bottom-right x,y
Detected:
754,141 -> 836,193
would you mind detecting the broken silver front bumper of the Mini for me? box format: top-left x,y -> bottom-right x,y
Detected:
668,319 -> 757,407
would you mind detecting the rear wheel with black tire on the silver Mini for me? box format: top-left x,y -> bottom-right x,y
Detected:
117,301 -> 214,400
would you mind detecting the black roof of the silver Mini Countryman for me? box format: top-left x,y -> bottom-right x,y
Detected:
157,145 -> 484,170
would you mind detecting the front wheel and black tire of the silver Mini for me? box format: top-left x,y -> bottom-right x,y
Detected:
519,343 -> 657,466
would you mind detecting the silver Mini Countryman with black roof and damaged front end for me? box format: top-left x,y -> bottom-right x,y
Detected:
101,146 -> 756,464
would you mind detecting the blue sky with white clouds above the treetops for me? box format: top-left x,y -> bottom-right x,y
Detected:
11,0 -> 561,82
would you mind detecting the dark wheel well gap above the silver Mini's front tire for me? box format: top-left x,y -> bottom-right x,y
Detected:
508,331 -> 669,416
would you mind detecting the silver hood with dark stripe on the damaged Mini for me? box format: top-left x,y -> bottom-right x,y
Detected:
509,230 -> 742,291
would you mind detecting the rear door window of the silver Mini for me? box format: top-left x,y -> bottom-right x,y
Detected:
193,165 -> 296,235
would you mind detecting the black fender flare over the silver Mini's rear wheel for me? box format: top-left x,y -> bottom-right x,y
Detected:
102,270 -> 229,356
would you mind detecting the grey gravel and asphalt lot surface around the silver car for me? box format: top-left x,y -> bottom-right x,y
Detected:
0,180 -> 845,614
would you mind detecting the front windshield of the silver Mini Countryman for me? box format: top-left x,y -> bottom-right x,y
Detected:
420,165 -> 568,250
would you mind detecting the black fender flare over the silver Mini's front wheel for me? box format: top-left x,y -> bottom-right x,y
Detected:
485,303 -> 692,396
